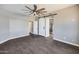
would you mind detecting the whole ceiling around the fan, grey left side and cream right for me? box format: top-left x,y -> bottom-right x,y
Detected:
0,4 -> 72,16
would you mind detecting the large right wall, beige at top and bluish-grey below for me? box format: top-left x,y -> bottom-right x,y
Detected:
53,5 -> 79,45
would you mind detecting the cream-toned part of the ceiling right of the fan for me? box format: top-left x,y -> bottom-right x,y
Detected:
38,4 -> 72,12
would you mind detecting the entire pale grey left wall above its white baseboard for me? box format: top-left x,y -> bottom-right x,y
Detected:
0,9 -> 28,43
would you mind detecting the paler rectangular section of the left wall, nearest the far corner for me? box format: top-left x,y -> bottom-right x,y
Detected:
9,19 -> 28,38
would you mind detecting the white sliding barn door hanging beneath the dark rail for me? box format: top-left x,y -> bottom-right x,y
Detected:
39,18 -> 45,36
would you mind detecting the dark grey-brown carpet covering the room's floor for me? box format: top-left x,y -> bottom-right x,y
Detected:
0,36 -> 79,54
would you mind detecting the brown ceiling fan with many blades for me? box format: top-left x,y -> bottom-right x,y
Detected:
25,4 -> 47,15
